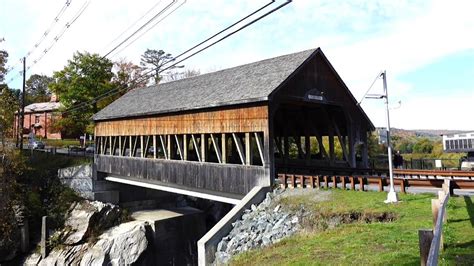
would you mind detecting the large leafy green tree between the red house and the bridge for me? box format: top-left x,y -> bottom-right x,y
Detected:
50,52 -> 115,136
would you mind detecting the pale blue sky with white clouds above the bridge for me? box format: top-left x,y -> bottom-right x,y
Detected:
0,0 -> 474,131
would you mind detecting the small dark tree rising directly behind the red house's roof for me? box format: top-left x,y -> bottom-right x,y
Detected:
25,74 -> 54,105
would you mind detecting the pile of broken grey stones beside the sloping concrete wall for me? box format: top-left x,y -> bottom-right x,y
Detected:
214,189 -> 312,265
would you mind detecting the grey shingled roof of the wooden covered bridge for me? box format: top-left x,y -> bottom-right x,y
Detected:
93,48 -> 320,121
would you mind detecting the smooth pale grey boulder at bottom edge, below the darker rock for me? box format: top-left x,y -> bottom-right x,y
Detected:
80,221 -> 149,265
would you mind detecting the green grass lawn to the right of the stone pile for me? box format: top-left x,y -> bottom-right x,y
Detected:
231,190 -> 474,265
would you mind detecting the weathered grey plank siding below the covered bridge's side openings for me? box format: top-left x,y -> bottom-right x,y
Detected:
95,155 -> 270,195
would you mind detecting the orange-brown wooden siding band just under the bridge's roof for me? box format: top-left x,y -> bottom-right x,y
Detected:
95,105 -> 268,136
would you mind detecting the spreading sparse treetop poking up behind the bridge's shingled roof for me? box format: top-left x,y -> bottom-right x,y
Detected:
140,49 -> 182,84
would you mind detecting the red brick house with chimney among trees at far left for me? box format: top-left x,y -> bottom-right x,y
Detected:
14,94 -> 62,139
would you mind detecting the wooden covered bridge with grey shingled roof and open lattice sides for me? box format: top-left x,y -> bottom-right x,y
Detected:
93,48 -> 373,203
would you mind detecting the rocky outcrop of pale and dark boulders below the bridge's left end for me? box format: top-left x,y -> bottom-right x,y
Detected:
24,200 -> 149,265
